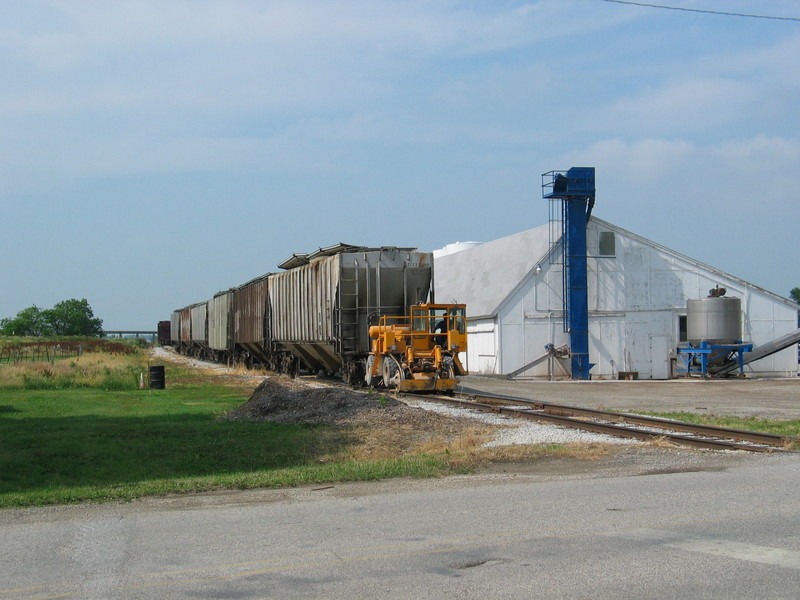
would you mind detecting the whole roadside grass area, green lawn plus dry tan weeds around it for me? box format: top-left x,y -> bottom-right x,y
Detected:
0,344 -> 588,508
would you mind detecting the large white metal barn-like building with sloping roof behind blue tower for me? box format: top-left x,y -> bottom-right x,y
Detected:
435,217 -> 800,379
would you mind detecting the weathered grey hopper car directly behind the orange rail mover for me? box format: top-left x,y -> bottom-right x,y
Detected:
269,244 -> 433,383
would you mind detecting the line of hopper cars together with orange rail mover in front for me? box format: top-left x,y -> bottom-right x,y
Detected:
169,244 -> 467,391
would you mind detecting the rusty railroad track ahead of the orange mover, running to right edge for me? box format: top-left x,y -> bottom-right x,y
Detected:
405,394 -> 800,452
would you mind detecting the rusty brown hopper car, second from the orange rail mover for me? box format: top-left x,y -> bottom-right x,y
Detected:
233,274 -> 275,368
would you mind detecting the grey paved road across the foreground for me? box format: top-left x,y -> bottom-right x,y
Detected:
0,455 -> 800,600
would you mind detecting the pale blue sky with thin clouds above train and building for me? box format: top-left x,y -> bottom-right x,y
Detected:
0,0 -> 800,330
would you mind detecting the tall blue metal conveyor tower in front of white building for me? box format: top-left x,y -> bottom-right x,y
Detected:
542,167 -> 595,379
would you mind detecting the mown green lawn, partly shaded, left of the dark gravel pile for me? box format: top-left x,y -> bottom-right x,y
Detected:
0,380 -> 460,507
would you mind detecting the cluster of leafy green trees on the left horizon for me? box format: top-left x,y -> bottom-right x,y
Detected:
0,298 -> 103,337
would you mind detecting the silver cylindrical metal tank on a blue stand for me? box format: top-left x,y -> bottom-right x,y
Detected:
686,296 -> 742,346
